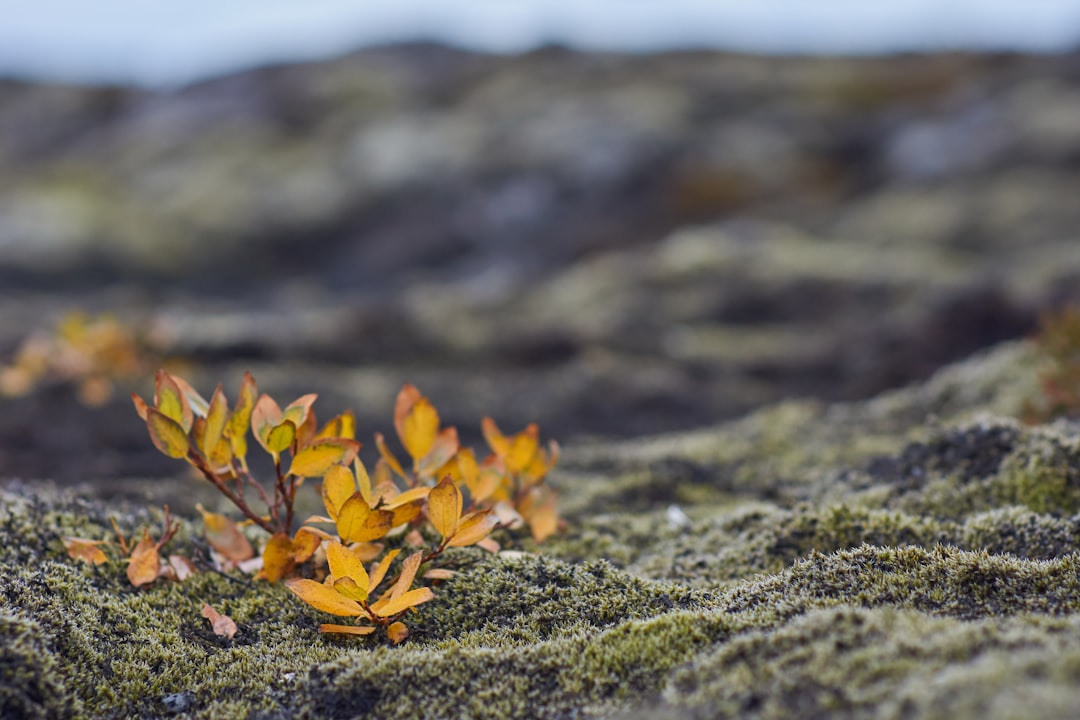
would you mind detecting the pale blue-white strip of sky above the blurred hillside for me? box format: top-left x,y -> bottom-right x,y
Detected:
6,0 -> 1080,86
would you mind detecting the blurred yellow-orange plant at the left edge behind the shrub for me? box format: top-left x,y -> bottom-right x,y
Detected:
0,312 -> 157,406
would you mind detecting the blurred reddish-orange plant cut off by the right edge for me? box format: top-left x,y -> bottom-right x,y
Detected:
1022,308 -> 1080,423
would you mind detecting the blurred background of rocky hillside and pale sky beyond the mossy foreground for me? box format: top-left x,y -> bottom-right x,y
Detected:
0,0 -> 1080,487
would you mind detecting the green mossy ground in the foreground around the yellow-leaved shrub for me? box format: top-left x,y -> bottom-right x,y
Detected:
0,347 -> 1080,718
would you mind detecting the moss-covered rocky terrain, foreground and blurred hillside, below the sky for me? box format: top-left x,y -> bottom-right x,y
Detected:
0,46 -> 1080,718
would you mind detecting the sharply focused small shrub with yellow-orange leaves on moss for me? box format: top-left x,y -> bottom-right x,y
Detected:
127,370 -> 558,642
